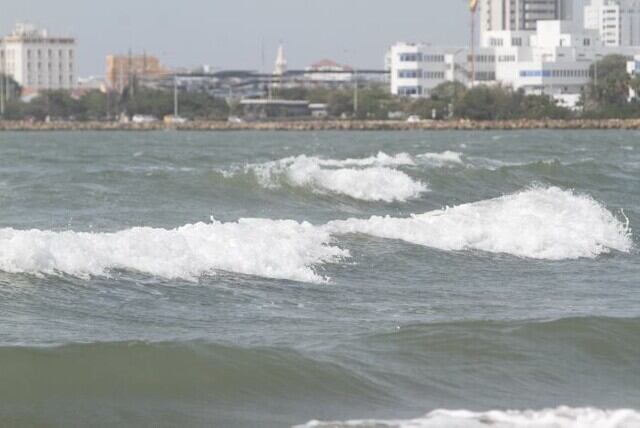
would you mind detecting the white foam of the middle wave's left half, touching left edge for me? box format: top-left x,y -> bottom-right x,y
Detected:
0,219 -> 349,282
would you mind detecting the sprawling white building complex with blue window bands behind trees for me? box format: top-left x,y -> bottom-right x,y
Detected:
389,0 -> 640,108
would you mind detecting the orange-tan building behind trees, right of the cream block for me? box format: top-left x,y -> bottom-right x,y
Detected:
106,55 -> 168,91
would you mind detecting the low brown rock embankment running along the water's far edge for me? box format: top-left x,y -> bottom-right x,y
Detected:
0,118 -> 640,132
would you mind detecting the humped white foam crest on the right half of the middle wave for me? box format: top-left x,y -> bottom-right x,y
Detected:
326,187 -> 632,260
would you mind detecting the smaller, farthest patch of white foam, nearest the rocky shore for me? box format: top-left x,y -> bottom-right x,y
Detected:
247,153 -> 427,202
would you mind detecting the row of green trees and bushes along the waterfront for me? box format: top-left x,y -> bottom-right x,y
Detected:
4,55 -> 640,121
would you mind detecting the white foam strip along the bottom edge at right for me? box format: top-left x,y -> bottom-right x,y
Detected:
298,407 -> 640,428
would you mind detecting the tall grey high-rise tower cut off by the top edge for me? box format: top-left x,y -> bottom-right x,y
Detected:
480,0 -> 573,32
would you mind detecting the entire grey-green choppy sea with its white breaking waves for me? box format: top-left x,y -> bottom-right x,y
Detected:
0,131 -> 640,428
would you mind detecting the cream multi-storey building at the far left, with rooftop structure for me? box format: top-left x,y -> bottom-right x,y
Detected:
0,24 -> 76,93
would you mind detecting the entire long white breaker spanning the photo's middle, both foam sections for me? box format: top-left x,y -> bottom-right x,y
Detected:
0,187 -> 632,282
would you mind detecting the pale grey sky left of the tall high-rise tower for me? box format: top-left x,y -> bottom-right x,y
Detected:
0,0 -> 476,76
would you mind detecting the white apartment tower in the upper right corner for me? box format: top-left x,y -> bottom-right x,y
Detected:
584,0 -> 640,46
